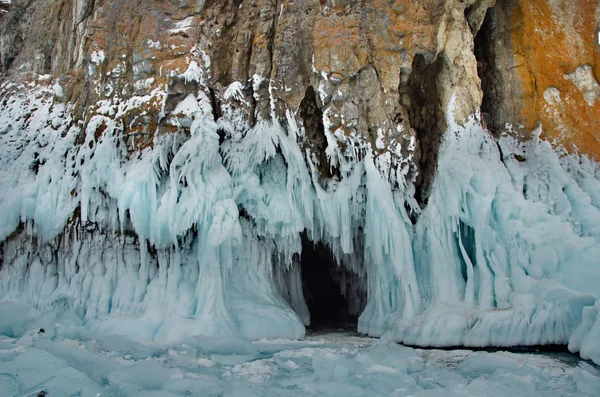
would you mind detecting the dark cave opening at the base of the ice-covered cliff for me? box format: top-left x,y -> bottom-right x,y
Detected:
300,235 -> 366,331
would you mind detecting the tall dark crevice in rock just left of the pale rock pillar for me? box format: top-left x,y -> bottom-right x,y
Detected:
401,54 -> 446,204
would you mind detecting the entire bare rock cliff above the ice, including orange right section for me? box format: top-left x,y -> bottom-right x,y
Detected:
1,0 -> 600,196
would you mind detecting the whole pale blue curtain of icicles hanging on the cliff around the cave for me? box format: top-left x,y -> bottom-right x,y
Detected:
0,51 -> 600,362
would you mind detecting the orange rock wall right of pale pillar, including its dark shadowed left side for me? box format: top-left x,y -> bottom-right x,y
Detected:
476,0 -> 600,160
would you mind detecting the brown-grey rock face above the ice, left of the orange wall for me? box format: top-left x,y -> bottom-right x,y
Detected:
2,0 -> 493,201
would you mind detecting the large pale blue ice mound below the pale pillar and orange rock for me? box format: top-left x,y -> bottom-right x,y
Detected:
393,102 -> 600,352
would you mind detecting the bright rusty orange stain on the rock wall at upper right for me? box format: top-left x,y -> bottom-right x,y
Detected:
511,0 -> 600,160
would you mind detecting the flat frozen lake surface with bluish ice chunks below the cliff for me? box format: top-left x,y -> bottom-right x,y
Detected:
0,331 -> 600,397
